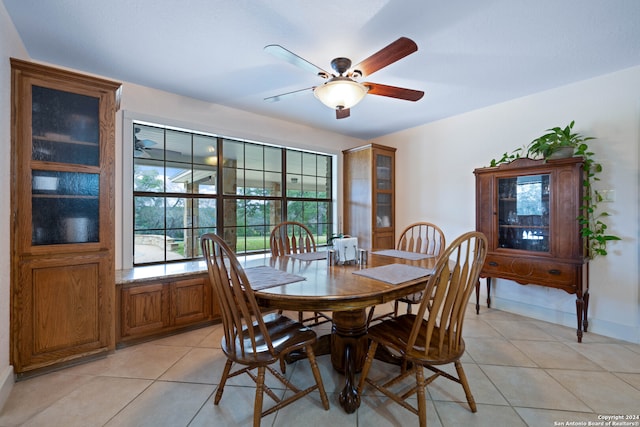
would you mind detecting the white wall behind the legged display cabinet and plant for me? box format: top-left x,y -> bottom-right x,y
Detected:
373,67 -> 640,342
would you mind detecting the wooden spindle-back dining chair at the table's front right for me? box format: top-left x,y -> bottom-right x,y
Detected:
358,231 -> 487,426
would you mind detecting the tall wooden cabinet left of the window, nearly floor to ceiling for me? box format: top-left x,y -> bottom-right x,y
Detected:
11,59 -> 120,374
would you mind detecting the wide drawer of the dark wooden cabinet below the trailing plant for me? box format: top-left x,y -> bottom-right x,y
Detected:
481,254 -> 581,292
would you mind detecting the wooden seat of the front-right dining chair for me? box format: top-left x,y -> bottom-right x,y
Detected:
367,314 -> 465,365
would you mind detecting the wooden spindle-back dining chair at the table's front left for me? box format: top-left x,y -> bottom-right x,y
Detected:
201,234 -> 329,426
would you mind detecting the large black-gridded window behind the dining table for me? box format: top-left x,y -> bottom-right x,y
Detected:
133,122 -> 333,265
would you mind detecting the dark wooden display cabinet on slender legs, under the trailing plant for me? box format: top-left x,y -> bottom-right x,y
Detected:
474,157 -> 589,342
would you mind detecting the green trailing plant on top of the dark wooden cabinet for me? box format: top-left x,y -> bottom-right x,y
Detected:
490,120 -> 621,259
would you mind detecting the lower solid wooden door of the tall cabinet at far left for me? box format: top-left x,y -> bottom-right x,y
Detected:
11,254 -> 114,372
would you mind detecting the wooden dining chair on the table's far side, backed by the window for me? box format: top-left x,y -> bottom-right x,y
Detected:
269,221 -> 331,325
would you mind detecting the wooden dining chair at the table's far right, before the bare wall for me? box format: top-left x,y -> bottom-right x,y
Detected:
368,222 -> 446,323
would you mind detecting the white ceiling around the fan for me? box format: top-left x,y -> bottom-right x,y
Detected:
1,0 -> 640,139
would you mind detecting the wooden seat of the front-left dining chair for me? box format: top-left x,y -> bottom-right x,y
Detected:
222,313 -> 316,365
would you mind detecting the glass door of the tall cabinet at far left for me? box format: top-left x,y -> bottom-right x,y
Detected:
31,85 -> 100,246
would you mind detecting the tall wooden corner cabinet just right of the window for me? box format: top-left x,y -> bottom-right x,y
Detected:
340,144 -> 396,250
